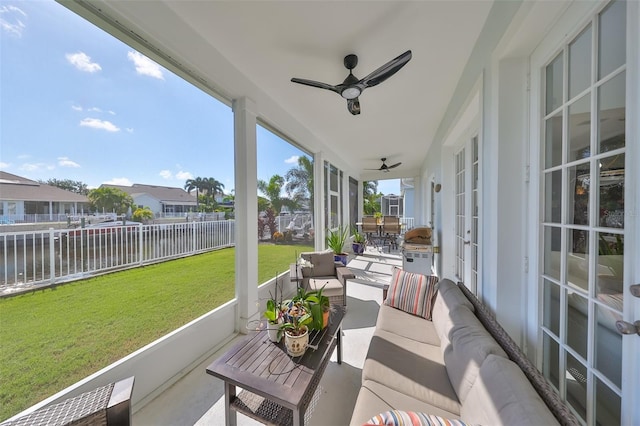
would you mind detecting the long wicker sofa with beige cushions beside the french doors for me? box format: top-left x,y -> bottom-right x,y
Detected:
351,275 -> 578,426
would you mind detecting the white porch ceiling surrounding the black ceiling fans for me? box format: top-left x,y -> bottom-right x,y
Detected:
76,0 -> 492,180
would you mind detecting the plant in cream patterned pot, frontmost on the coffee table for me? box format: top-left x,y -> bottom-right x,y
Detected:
280,289 -> 313,357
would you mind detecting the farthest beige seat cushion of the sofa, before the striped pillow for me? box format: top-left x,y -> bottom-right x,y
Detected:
376,305 -> 440,346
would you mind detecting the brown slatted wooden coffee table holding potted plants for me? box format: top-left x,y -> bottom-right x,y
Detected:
207,305 -> 344,426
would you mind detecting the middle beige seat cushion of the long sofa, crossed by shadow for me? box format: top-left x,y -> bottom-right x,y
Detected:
362,332 -> 460,415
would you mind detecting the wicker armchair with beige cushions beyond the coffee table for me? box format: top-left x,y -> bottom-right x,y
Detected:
291,251 -> 355,306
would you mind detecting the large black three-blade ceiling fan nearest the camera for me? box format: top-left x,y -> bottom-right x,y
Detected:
291,50 -> 411,115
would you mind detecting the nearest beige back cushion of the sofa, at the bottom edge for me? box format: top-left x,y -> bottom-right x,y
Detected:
460,355 -> 558,426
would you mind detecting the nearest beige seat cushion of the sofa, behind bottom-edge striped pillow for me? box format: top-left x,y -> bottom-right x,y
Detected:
350,380 -> 459,426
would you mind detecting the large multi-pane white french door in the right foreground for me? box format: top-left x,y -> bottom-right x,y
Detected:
539,0 -> 640,425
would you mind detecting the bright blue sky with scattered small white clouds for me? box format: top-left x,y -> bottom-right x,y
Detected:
0,0 -> 399,194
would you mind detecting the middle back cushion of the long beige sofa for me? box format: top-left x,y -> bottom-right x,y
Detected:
444,309 -> 507,403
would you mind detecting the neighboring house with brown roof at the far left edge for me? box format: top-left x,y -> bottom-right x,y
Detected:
0,171 -> 89,223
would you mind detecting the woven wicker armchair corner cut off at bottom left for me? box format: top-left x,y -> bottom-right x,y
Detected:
0,377 -> 134,426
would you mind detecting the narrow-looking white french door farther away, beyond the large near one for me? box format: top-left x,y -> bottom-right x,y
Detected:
454,136 -> 480,294
